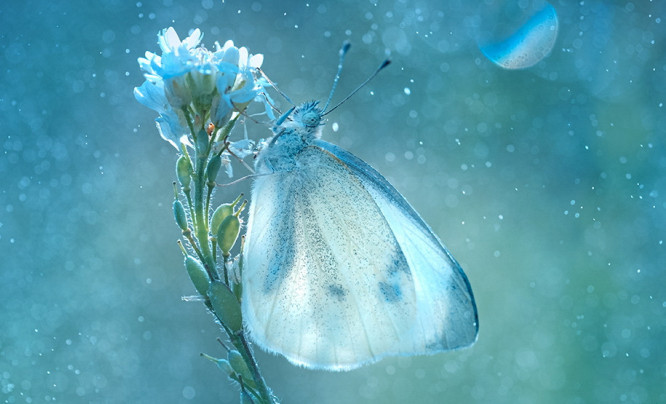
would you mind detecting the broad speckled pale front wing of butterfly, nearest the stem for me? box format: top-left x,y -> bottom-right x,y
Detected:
243,147 -> 417,369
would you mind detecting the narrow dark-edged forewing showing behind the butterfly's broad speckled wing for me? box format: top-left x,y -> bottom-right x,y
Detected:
315,140 -> 479,353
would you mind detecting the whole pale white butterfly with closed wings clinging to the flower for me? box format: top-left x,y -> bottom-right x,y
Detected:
241,49 -> 478,370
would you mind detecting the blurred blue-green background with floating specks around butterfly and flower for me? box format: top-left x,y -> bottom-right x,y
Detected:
0,0 -> 666,404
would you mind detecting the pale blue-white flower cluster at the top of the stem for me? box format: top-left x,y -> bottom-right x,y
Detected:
134,28 -> 266,150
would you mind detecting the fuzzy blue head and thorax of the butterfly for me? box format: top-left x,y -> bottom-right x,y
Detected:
255,101 -> 324,174
